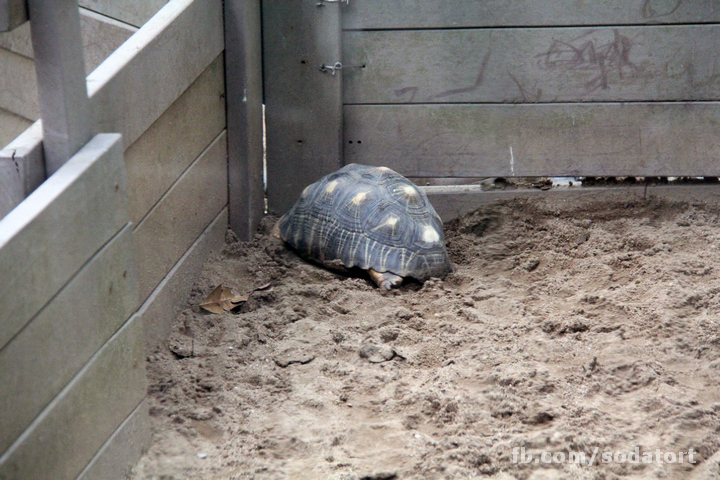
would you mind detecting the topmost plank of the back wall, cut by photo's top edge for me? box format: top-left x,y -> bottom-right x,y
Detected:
342,0 -> 720,29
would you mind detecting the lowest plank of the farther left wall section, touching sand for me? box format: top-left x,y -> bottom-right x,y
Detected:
138,208 -> 228,354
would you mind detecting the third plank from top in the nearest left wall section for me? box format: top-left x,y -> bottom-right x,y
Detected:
0,315 -> 147,480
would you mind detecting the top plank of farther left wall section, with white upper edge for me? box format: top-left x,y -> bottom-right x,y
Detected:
87,0 -> 224,148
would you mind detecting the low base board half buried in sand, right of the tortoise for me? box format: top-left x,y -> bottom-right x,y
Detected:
428,185 -> 720,222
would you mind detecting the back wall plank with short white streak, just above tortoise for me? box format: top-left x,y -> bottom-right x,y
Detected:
344,102 -> 720,177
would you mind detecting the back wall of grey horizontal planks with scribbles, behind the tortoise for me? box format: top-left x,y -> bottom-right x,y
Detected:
342,0 -> 720,177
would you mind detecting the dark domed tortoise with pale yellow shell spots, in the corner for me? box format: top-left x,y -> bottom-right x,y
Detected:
275,163 -> 450,290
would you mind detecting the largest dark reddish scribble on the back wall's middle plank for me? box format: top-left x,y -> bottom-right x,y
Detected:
536,29 -> 643,93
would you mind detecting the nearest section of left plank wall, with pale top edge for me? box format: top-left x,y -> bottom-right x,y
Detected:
0,134 -> 145,479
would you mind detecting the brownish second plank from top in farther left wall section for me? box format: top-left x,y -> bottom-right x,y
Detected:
125,55 -> 225,225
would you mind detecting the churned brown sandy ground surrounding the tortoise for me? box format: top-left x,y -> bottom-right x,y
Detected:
132,193 -> 720,480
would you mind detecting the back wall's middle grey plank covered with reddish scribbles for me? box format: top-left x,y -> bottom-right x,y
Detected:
342,25 -> 720,104
